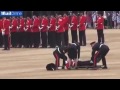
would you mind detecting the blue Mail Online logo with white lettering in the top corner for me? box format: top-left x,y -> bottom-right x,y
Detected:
0,11 -> 23,16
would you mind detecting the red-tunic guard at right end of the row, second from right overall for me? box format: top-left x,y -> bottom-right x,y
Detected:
79,13 -> 87,46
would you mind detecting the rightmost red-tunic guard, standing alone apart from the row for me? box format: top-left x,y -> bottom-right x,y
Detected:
96,13 -> 104,43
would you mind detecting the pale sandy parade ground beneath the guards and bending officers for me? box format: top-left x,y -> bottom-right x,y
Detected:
0,29 -> 120,79
